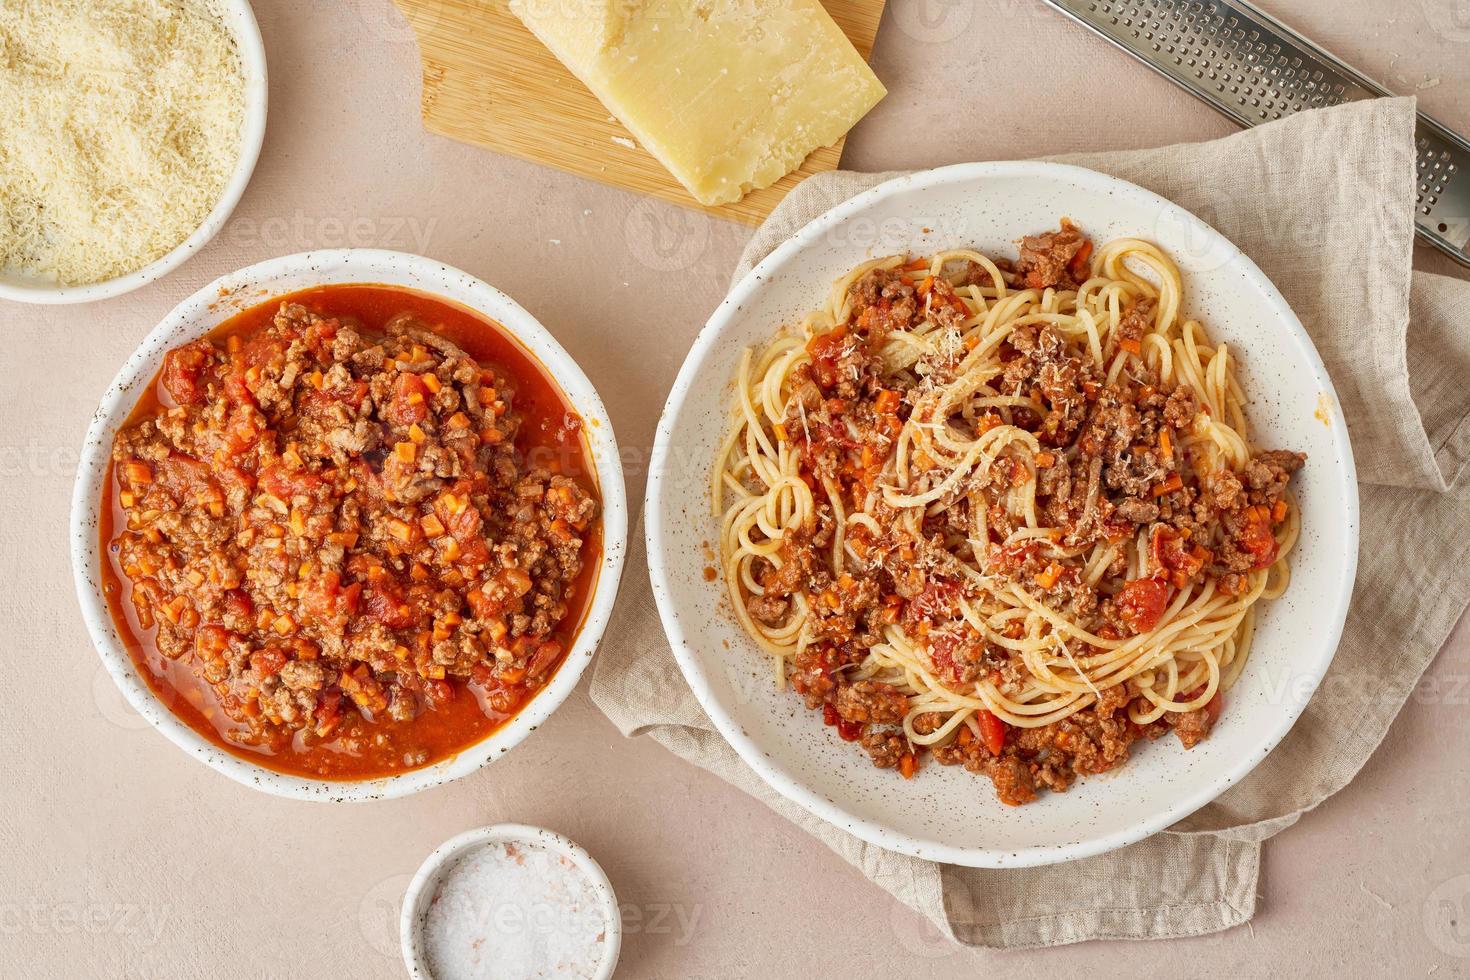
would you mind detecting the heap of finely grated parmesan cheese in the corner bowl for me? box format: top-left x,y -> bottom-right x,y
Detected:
0,0 -> 245,285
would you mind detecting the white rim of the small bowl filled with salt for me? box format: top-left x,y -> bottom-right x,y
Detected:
398,823 -> 623,980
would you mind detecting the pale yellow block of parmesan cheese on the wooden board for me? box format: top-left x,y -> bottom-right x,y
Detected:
510,0 -> 885,204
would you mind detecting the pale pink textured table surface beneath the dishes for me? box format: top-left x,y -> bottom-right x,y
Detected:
0,0 -> 1470,979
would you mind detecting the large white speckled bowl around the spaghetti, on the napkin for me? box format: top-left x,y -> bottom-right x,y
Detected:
645,162 -> 1358,867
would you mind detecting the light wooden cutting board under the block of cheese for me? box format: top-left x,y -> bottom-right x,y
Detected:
394,0 -> 883,225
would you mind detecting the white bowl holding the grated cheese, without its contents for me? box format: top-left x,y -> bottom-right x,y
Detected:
0,0 -> 268,306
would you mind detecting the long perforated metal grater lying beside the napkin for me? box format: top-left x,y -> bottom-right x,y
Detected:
1047,0 -> 1470,266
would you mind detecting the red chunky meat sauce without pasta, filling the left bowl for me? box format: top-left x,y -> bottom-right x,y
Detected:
101,285 -> 601,779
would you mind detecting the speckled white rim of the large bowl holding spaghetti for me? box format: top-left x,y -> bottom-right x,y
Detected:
644,160 -> 1358,868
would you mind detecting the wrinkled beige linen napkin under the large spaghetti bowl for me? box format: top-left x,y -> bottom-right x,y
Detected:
592,98 -> 1470,948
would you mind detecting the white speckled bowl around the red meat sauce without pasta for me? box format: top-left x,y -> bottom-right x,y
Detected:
71,248 -> 628,801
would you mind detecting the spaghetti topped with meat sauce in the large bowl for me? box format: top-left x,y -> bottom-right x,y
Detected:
713,220 -> 1305,804
